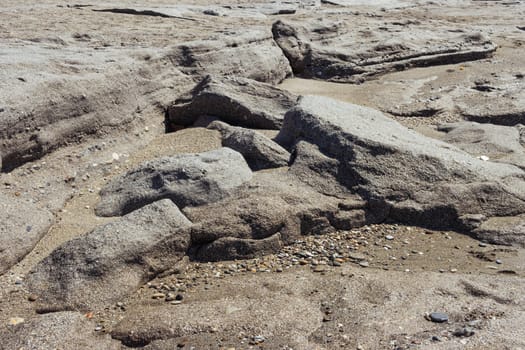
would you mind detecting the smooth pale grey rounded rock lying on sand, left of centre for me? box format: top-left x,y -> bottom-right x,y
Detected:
96,147 -> 252,216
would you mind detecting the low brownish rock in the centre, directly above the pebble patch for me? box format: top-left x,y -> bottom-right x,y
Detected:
184,169 -> 368,261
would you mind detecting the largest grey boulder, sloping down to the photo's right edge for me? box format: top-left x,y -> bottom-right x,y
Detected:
277,96 -> 525,243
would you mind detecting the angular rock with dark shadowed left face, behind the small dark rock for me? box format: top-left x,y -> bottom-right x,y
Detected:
167,76 -> 297,129
